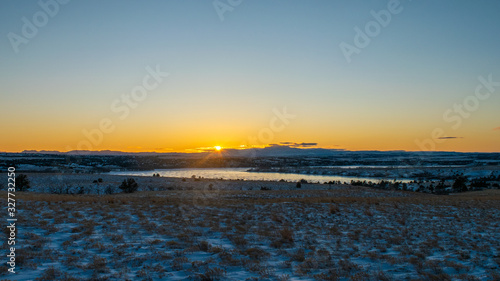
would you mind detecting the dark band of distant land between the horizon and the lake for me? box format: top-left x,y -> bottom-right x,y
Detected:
0,151 -> 500,173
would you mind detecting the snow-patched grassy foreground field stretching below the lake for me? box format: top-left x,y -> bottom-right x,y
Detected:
0,176 -> 500,280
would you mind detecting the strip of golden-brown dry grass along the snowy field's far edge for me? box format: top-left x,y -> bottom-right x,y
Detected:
6,187 -> 500,210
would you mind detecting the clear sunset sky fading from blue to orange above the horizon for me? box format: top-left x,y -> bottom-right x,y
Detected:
0,0 -> 500,152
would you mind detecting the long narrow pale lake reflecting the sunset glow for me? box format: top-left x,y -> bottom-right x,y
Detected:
110,168 -> 409,183
